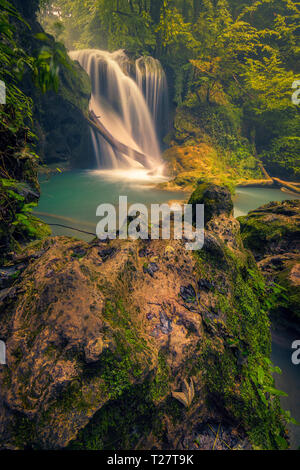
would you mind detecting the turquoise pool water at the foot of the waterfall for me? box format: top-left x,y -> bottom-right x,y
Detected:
38,170 -> 300,240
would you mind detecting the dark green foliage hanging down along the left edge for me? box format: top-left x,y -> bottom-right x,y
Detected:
0,0 -> 63,258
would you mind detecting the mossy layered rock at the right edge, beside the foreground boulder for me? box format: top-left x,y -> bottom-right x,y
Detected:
239,199 -> 300,327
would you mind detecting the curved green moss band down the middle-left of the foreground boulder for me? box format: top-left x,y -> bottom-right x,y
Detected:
35,301 -> 149,434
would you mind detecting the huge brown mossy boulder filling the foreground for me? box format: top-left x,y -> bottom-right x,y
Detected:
0,188 -> 285,449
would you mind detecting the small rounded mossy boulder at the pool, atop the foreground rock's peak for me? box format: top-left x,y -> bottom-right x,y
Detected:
189,183 -> 233,224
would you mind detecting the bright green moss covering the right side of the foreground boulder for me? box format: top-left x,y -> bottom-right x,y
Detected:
192,241 -> 286,449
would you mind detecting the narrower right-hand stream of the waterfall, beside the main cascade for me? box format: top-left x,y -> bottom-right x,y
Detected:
135,56 -> 169,138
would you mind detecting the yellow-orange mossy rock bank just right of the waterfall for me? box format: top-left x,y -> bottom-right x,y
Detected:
163,101 -> 262,189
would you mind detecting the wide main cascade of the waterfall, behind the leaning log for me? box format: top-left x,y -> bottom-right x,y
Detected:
70,49 -> 162,171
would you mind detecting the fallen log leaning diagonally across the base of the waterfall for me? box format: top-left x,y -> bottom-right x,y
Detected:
87,111 -> 149,168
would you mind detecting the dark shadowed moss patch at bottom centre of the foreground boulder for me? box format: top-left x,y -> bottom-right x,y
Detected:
69,354 -> 178,450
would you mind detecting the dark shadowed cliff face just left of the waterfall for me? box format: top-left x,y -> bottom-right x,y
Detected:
12,0 -> 95,168
